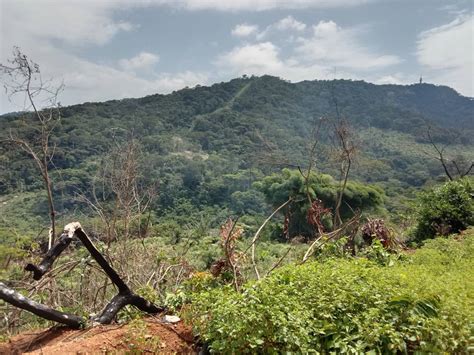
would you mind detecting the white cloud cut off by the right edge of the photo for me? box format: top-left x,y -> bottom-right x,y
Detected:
416,14 -> 474,97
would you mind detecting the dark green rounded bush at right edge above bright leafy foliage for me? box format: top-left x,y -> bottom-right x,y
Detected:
413,178 -> 474,241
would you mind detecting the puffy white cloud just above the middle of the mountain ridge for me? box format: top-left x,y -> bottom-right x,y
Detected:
216,18 -> 401,82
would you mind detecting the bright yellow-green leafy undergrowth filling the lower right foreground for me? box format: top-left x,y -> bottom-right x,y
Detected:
184,232 -> 474,353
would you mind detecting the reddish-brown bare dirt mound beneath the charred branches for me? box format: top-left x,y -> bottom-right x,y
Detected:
0,318 -> 197,354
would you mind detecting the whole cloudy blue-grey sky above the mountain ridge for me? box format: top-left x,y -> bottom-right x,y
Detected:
0,0 -> 474,113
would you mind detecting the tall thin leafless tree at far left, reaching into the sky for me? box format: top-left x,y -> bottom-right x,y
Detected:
0,47 -> 64,248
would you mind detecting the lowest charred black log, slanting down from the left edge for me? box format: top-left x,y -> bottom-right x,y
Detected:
0,282 -> 86,328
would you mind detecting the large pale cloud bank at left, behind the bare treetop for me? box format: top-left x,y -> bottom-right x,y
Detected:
0,0 -> 208,113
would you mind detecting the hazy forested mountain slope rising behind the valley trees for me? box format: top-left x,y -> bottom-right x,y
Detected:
0,76 -> 474,224
